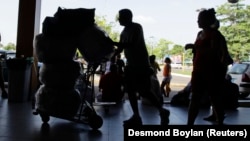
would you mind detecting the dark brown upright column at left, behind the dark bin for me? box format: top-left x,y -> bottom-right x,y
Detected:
16,0 -> 41,101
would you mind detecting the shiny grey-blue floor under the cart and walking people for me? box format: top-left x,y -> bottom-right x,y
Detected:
0,91 -> 250,141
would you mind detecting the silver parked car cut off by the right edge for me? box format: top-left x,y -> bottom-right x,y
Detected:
227,62 -> 250,98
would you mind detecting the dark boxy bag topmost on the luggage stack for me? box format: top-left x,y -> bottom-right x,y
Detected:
42,7 -> 95,36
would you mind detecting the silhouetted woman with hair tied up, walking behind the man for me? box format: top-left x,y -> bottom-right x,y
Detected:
185,9 -> 227,125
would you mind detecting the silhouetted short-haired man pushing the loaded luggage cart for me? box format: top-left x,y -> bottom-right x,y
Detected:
113,9 -> 170,126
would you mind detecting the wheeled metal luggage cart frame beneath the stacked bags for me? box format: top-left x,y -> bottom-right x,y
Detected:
33,61 -> 103,130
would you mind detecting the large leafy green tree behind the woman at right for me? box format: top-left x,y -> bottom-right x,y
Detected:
216,0 -> 250,60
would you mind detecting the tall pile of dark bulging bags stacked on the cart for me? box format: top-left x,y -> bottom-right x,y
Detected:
34,7 -> 114,117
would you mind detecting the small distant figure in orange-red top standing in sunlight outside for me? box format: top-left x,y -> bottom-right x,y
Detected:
161,57 -> 172,97
